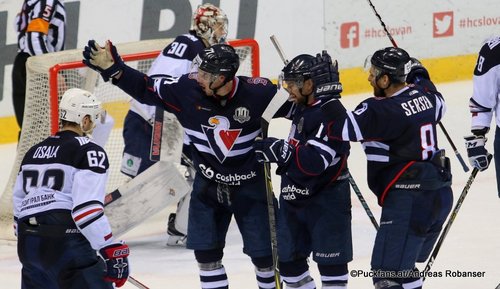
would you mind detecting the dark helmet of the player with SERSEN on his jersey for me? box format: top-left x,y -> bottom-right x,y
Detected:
371,47 -> 411,83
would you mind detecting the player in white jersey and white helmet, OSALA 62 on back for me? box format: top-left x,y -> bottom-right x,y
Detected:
13,88 -> 129,289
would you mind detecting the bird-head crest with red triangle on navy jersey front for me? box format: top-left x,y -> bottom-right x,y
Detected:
202,115 -> 241,163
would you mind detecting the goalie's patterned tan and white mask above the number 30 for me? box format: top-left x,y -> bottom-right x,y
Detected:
191,3 -> 228,45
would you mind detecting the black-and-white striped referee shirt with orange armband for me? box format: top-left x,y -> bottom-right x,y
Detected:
15,0 -> 66,56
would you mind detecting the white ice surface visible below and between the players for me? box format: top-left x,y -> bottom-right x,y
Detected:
0,81 -> 500,289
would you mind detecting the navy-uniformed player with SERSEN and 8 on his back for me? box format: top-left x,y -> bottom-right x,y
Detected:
322,47 -> 453,289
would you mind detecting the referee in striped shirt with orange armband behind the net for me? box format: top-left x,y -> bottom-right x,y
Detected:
12,0 -> 66,136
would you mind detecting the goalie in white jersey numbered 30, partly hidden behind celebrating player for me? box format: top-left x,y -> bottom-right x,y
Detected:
121,3 -> 227,245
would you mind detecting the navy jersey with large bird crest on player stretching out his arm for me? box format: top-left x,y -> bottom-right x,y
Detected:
115,67 -> 276,185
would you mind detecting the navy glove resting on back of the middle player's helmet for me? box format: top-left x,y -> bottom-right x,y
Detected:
311,50 -> 342,98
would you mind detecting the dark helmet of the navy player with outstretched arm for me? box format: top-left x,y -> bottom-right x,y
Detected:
199,44 -> 240,81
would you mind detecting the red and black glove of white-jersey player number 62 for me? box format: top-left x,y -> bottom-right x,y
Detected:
99,243 -> 129,287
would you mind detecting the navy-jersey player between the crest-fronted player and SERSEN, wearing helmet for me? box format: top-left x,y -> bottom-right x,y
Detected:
254,54 -> 352,289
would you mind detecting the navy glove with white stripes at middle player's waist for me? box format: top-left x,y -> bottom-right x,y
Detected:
253,137 -> 294,166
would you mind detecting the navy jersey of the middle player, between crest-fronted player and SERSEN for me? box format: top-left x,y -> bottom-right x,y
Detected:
277,99 -> 350,201
